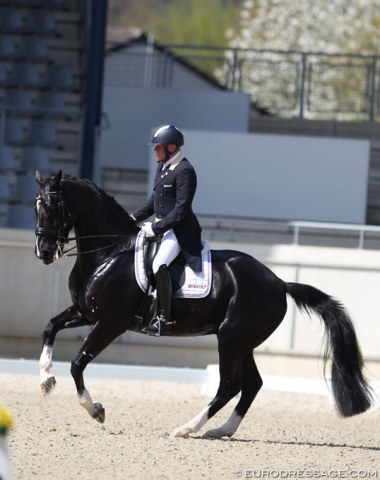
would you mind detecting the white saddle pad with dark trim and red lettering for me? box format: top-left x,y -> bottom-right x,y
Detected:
135,231 -> 212,298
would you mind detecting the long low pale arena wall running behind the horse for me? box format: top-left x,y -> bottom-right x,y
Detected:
0,229 -> 380,367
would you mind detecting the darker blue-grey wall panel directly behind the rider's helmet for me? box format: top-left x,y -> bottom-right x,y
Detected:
98,86 -> 250,170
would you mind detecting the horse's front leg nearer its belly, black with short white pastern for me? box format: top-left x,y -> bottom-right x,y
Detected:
71,321 -> 126,423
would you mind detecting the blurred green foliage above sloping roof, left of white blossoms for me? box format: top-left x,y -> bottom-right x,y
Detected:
108,0 -> 242,81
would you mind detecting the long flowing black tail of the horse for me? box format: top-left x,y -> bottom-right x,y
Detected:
286,283 -> 372,417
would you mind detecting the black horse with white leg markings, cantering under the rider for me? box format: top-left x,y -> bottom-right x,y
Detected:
35,172 -> 371,438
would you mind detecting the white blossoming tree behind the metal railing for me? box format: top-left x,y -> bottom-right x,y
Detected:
219,0 -> 380,117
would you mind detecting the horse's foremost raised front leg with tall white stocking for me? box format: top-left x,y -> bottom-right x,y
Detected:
39,305 -> 88,395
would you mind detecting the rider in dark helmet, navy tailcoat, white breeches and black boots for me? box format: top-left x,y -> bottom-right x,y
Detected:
131,125 -> 202,336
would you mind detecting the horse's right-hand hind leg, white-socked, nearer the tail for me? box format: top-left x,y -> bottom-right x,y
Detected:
205,353 -> 263,438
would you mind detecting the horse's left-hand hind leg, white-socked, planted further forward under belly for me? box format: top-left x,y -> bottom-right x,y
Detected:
171,344 -> 242,438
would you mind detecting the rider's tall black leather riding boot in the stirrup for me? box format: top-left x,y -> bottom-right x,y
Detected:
143,265 -> 172,337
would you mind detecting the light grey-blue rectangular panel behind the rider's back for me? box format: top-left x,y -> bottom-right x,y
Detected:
148,130 -> 370,224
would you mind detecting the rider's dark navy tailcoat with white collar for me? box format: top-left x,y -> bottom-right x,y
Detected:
133,157 -> 202,272
